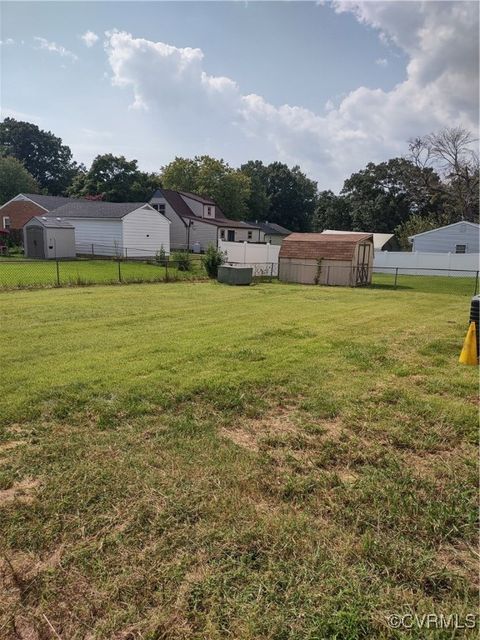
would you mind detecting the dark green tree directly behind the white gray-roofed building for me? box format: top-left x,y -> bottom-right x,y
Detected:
69,153 -> 160,202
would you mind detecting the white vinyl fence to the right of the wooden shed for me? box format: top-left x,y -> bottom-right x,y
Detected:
373,251 -> 480,277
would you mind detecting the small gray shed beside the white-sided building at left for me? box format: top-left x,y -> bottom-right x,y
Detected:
23,216 -> 76,259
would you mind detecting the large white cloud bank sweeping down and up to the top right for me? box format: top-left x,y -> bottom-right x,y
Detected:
100,2 -> 478,188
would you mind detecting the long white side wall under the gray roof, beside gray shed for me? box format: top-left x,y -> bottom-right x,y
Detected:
68,218 -> 123,256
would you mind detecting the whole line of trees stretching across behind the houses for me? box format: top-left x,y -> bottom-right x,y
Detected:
0,118 -> 479,248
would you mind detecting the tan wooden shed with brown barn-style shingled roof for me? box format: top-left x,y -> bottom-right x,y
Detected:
278,233 -> 373,287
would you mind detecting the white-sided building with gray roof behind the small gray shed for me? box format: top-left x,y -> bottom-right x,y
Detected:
49,200 -> 171,258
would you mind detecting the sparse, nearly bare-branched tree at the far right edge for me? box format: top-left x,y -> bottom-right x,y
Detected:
409,127 -> 479,222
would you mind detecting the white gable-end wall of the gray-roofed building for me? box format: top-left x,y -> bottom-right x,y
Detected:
122,207 -> 170,257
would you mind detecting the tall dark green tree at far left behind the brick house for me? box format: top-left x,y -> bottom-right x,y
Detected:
0,118 -> 79,195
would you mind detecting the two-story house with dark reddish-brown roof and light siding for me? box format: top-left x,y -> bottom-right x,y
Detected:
150,189 -> 264,251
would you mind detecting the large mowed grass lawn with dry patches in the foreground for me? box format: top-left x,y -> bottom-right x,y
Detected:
0,282 -> 478,640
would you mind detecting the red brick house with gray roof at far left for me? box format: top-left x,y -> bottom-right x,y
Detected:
0,193 -> 78,238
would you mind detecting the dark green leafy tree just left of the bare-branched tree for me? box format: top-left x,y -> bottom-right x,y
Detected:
341,158 -> 442,233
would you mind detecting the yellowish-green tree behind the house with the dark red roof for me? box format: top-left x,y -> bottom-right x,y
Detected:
161,156 -> 250,220
